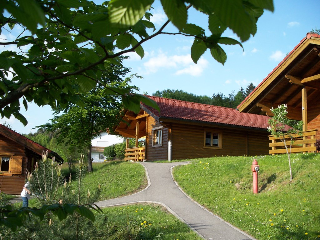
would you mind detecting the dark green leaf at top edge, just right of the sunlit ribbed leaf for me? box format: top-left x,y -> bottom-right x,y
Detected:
161,0 -> 188,31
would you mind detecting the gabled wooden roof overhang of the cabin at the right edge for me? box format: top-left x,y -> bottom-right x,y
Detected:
238,34 -> 320,120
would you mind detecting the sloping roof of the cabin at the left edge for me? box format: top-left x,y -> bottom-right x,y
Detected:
0,124 -> 63,162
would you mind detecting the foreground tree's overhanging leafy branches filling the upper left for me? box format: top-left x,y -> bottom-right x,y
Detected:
0,0 -> 274,124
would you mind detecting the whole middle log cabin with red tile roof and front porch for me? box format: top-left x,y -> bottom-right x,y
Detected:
115,96 -> 269,161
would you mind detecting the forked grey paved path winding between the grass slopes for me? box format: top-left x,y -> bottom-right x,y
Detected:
96,162 -> 253,240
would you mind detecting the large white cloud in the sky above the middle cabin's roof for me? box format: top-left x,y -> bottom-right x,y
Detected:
143,51 -> 208,76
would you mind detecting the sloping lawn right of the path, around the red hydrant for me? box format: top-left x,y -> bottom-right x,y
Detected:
174,154 -> 320,240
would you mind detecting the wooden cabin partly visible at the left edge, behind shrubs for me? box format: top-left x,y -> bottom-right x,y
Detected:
0,124 -> 63,194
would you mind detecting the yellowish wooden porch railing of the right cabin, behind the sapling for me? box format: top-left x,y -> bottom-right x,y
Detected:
269,130 -> 317,154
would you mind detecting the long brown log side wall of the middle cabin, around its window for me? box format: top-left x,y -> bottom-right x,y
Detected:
171,124 -> 269,160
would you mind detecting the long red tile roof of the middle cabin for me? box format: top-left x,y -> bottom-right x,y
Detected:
142,96 -> 269,129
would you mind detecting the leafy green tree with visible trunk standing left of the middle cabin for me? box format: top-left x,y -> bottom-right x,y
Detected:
40,61 -> 134,172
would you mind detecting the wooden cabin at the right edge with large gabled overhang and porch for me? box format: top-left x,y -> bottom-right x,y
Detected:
238,33 -> 320,154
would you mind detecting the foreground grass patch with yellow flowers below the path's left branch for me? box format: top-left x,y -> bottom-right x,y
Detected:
99,204 -> 202,240
